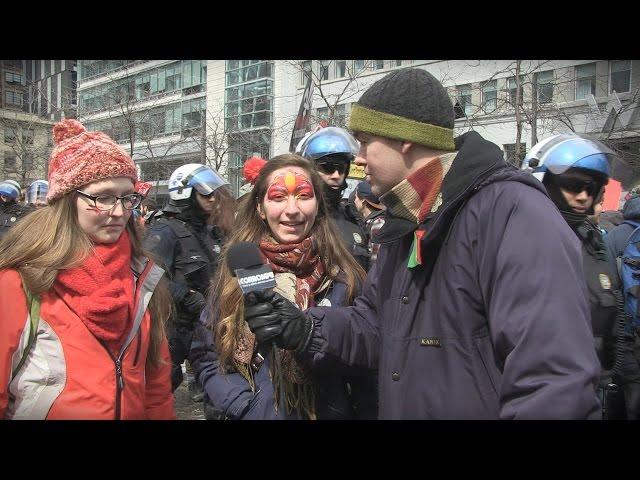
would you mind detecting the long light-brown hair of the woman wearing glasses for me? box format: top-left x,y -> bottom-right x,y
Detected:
0,193 -> 172,367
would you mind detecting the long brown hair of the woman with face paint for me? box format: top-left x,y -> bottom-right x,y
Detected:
208,153 -> 365,367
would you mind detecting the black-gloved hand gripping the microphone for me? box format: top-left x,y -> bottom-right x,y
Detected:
244,291 -> 313,352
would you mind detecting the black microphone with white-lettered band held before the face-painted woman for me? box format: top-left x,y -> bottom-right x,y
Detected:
227,242 -> 276,296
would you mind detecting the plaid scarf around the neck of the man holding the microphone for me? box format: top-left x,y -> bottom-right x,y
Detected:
380,152 -> 457,224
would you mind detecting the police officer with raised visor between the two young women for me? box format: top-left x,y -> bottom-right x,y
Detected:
145,163 -> 235,390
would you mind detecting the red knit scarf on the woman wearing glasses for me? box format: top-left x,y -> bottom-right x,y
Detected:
53,230 -> 134,356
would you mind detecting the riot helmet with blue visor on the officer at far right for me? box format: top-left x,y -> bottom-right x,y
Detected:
522,133 -> 619,183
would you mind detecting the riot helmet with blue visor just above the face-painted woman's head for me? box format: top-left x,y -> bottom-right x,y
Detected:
296,127 -> 360,175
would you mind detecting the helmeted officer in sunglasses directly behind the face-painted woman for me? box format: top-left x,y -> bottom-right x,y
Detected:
296,127 -> 369,270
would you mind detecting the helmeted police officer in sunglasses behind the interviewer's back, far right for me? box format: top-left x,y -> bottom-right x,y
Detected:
525,134 -> 640,419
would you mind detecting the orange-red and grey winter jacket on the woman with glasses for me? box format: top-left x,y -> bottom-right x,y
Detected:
0,260 -> 175,420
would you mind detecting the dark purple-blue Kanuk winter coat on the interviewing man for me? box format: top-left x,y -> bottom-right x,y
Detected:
307,132 -> 600,419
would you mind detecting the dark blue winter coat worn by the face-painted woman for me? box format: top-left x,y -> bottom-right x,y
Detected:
189,282 -> 376,420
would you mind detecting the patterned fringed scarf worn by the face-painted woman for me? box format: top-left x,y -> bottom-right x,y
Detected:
234,237 -> 325,419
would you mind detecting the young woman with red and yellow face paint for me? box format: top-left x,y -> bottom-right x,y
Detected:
191,154 -> 376,420
